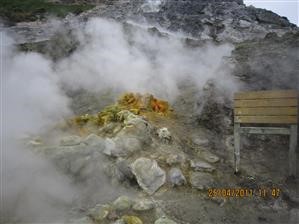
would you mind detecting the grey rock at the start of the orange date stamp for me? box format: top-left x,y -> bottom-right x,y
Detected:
190,172 -> 214,190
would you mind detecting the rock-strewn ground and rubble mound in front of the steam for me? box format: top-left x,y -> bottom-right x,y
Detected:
15,91 -> 299,224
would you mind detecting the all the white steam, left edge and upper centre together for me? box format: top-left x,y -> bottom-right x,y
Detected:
1,17 -> 236,222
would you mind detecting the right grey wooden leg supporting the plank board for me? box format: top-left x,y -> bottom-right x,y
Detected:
289,125 -> 297,177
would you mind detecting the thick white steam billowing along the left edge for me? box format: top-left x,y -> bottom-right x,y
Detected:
0,33 -> 75,223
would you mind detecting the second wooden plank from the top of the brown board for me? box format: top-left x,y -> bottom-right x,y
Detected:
235,98 -> 298,108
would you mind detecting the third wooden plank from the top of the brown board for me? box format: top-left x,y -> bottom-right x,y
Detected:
235,107 -> 298,116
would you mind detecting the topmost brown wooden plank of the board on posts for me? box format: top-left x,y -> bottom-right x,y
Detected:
234,90 -> 298,100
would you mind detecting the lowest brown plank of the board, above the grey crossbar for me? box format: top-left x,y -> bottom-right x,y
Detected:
235,116 -> 298,124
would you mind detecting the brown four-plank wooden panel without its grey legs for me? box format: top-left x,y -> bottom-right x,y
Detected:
234,90 -> 298,124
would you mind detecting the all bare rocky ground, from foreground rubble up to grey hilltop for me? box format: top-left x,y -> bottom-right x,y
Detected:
5,0 -> 299,224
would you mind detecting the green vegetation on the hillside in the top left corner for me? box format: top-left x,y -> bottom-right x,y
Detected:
0,0 -> 94,23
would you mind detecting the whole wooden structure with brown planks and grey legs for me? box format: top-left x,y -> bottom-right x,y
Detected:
234,90 -> 298,177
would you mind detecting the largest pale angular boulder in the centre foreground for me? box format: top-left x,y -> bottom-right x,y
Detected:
131,158 -> 166,194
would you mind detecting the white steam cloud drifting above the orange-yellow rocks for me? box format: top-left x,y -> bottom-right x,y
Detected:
57,18 -> 236,100
